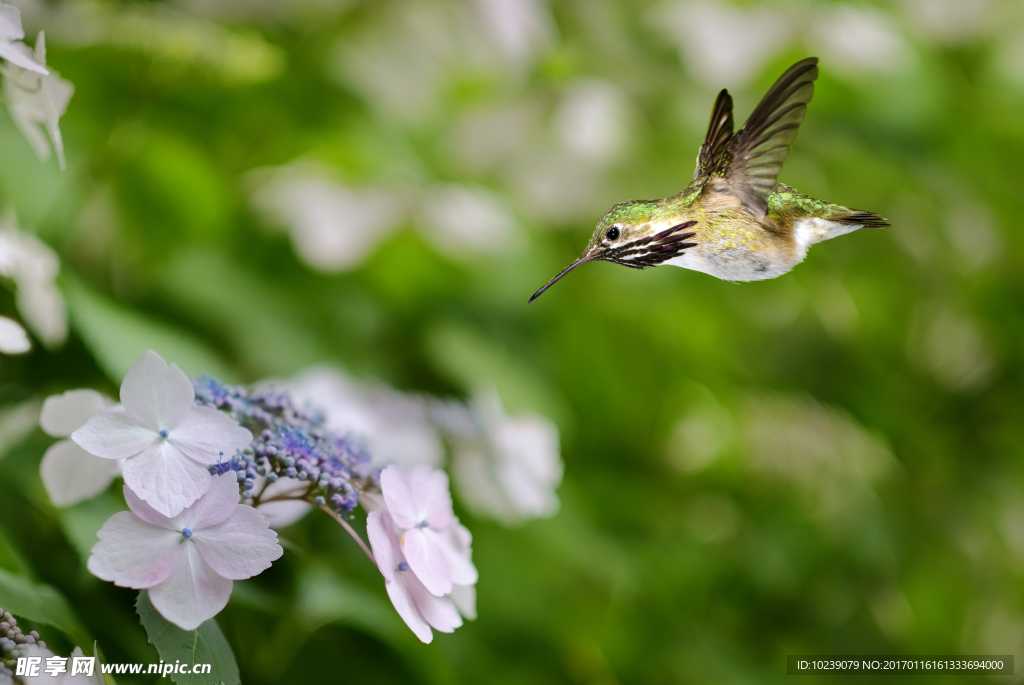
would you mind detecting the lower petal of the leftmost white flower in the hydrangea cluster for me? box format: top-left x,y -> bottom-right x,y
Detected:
39,440 -> 118,507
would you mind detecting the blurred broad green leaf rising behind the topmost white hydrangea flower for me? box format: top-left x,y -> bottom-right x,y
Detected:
65,279 -> 236,384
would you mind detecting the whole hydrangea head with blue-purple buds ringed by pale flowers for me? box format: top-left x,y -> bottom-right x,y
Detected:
40,351 -> 524,642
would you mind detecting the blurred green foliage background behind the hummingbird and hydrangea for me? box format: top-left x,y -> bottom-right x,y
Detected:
0,0 -> 1024,684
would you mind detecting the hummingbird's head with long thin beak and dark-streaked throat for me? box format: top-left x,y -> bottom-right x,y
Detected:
529,200 -> 696,302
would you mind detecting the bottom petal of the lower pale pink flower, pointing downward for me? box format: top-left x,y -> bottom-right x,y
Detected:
150,541 -> 232,631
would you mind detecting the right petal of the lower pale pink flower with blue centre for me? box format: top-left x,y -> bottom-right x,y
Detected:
191,504 -> 285,581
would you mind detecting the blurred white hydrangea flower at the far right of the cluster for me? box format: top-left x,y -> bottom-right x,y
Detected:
453,392 -> 562,523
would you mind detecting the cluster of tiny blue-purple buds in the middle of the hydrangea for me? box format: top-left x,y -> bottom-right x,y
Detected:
193,376 -> 373,513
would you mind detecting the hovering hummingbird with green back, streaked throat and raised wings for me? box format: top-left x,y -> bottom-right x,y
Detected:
529,57 -> 889,302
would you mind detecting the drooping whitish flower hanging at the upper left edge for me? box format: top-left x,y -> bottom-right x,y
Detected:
3,31 -> 75,169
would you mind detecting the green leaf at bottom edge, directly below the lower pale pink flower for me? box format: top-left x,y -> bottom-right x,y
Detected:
135,590 -> 242,685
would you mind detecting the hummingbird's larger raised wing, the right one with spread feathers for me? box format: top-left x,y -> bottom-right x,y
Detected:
713,57 -> 818,216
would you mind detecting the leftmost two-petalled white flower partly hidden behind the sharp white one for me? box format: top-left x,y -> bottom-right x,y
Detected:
39,389 -> 121,507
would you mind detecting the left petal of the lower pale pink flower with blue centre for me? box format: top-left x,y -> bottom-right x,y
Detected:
86,511 -> 181,590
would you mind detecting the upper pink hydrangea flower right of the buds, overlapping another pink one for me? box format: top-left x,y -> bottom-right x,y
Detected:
380,465 -> 477,597
